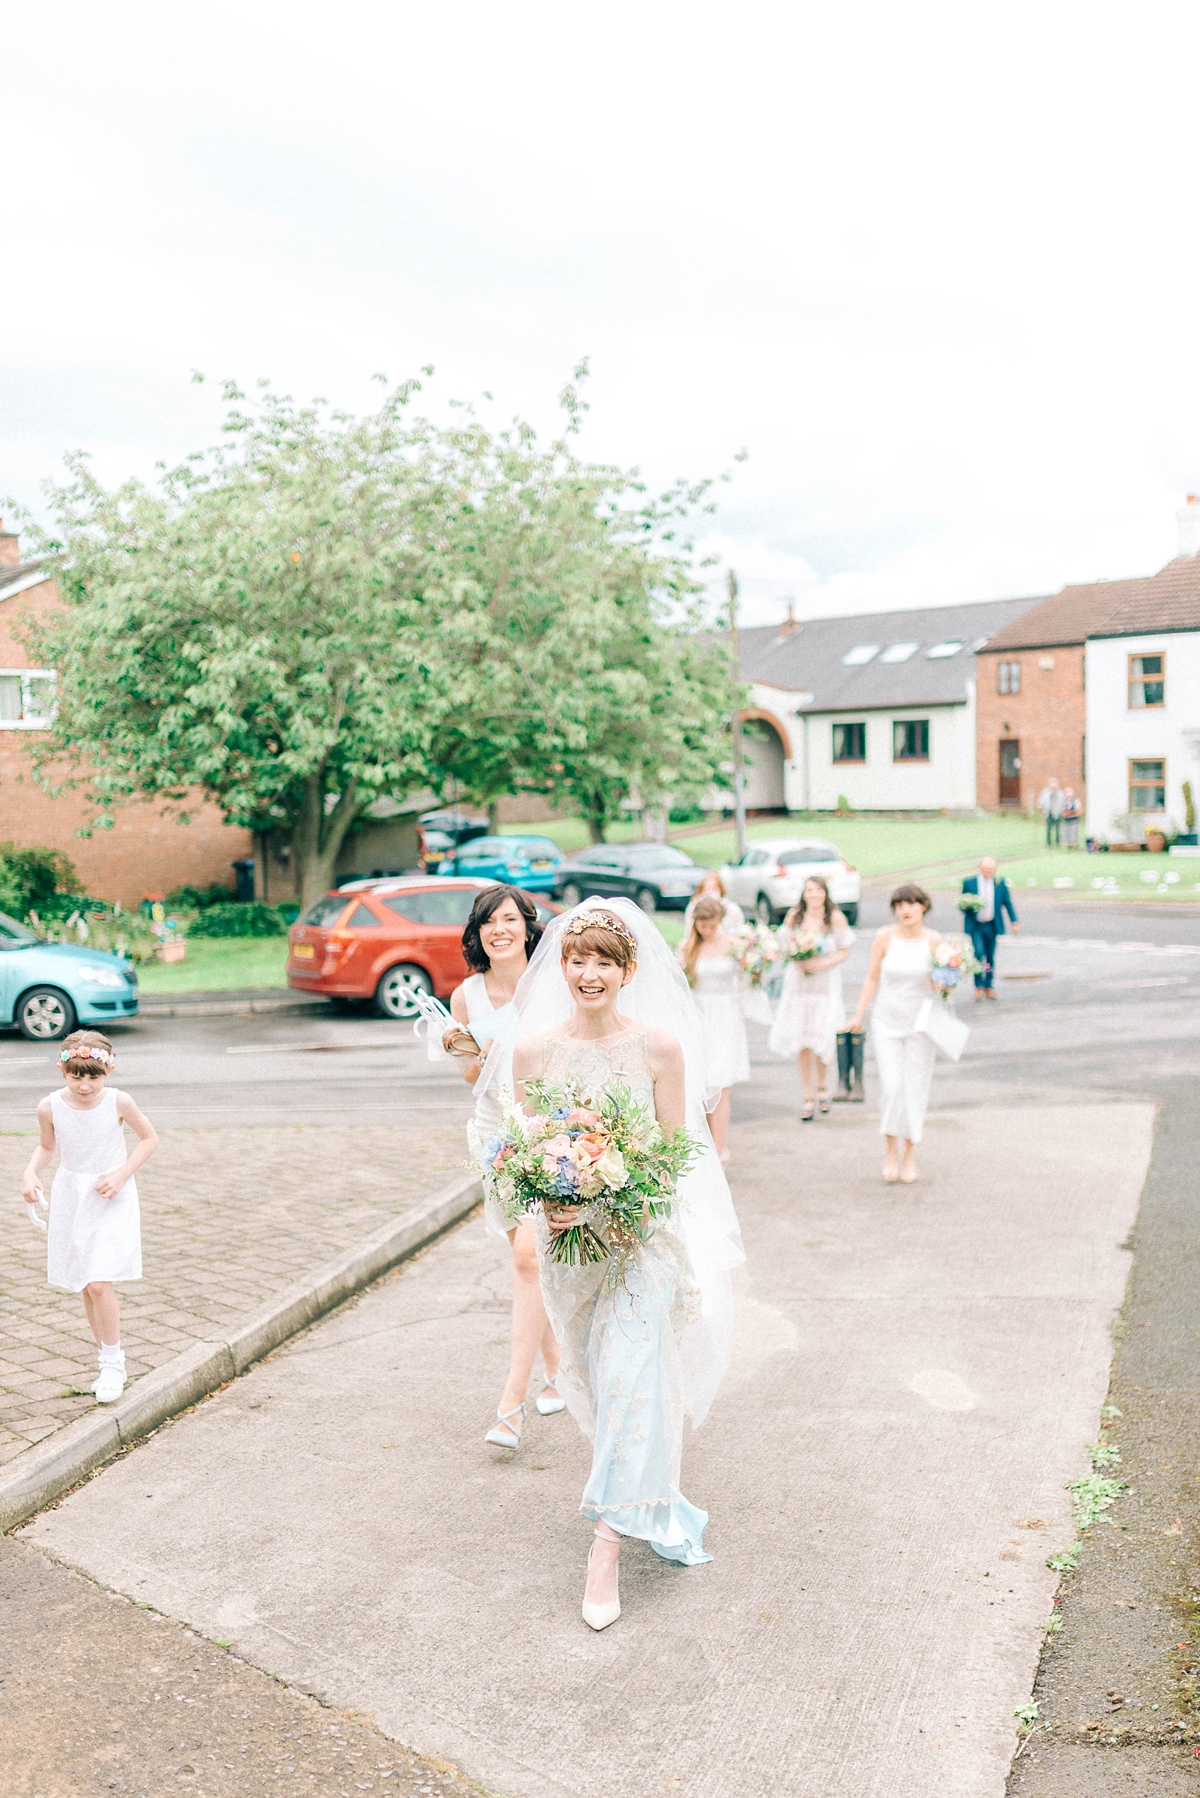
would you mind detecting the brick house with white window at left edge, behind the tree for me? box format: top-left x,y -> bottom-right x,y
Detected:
0,523 -> 254,906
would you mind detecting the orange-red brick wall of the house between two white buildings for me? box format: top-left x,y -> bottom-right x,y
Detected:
975,644 -> 1087,811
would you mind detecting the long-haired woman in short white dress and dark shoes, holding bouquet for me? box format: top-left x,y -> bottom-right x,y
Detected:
766,874 -> 855,1124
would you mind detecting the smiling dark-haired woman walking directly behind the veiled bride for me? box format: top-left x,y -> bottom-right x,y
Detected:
446,886 -> 565,1449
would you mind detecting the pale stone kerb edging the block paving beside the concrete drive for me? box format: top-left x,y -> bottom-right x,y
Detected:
0,1174 -> 482,1532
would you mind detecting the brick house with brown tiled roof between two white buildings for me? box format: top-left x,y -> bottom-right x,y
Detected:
975,581 -> 1142,811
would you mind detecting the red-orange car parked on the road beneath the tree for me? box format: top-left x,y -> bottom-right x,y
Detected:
288,874 -> 556,1018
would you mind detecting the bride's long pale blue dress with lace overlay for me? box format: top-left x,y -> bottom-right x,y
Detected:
536,1030 -> 712,1566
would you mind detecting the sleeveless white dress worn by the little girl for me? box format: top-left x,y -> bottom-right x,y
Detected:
45,1086 -> 142,1293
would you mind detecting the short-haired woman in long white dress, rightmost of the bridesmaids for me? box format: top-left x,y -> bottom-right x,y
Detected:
849,885 -> 941,1185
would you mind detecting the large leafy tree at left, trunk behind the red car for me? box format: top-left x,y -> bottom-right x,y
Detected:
19,385 -> 453,903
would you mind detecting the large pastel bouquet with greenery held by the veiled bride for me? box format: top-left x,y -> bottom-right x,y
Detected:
484,1081 -> 700,1268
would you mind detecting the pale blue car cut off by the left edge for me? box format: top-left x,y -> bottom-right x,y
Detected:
0,913 -> 137,1043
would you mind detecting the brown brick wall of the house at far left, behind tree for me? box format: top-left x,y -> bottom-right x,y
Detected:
0,581 -> 253,906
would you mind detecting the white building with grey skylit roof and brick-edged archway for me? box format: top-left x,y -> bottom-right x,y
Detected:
739,599 -> 1036,811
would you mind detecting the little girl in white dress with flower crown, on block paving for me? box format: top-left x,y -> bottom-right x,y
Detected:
23,1030 -> 158,1404
